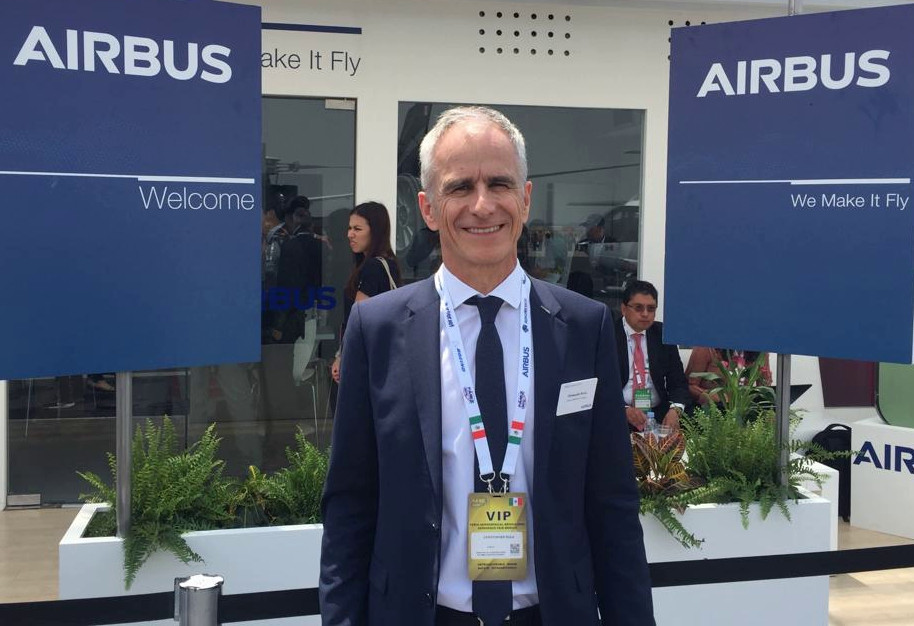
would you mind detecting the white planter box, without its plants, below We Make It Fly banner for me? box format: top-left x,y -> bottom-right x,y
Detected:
641,493 -> 833,626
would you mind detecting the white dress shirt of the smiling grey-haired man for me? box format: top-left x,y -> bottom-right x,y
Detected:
438,263 -> 539,612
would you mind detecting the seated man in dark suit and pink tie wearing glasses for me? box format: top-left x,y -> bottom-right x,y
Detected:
616,280 -> 691,430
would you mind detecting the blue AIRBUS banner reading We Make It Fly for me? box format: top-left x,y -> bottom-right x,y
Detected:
664,5 -> 914,363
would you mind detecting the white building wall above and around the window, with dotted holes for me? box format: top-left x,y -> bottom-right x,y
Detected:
255,0 -> 786,304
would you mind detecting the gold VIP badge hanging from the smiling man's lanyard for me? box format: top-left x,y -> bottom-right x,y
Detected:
467,492 -> 527,580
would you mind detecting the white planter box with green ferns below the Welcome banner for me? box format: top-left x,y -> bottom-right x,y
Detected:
59,418 -> 328,599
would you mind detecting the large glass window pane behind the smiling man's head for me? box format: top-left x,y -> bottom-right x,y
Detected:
397,102 -> 644,310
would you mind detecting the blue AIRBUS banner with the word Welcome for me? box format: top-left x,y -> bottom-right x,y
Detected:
0,0 -> 262,378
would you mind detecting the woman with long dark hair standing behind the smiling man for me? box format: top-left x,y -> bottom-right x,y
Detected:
330,202 -> 400,383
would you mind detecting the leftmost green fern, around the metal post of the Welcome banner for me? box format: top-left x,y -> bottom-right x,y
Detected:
79,416 -> 232,589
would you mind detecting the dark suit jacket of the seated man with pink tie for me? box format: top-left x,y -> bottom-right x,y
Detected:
616,318 -> 692,422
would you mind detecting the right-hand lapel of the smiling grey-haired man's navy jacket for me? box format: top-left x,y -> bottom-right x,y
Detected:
530,280 -> 568,491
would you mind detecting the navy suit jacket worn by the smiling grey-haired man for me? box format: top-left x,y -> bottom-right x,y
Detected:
320,279 -> 654,626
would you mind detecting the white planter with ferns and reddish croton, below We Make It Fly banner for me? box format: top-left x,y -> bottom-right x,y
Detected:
633,362 -> 835,626
